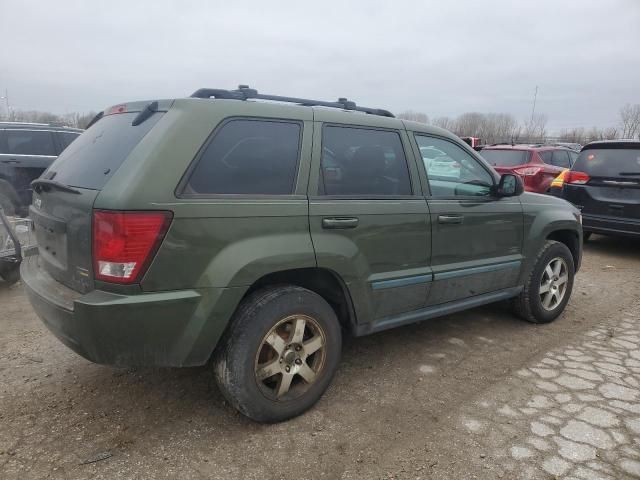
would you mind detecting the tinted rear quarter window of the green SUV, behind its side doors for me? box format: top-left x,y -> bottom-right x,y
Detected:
183,119 -> 302,195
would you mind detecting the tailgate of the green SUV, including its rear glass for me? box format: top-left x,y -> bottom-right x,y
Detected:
30,107 -> 164,293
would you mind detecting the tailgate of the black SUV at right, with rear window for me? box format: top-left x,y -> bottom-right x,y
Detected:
563,143 -> 640,225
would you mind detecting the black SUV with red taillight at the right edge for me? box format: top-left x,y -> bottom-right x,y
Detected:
562,140 -> 640,238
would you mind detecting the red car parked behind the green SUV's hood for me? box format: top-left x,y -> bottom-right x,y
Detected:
480,144 -> 578,193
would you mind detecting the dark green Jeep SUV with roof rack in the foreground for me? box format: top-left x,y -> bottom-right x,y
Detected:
21,86 -> 582,422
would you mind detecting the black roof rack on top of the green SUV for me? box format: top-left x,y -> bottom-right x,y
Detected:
191,85 -> 395,117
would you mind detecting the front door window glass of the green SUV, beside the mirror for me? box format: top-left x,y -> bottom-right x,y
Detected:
416,135 -> 493,197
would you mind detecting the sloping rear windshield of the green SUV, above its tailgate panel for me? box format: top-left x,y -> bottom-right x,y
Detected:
45,112 -> 164,190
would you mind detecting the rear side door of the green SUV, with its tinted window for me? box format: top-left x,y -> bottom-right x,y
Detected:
309,112 -> 431,328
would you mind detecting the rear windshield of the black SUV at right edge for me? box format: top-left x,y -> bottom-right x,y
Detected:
573,148 -> 640,177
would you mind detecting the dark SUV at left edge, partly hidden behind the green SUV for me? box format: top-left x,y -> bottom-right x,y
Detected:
0,122 -> 82,216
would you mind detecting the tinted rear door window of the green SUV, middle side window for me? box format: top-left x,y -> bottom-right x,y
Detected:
320,126 -> 411,196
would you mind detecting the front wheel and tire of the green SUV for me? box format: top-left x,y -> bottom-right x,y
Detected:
513,240 -> 575,323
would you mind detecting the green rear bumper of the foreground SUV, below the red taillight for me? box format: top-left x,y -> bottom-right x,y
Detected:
20,256 -> 242,366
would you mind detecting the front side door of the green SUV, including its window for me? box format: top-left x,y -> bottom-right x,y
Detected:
414,133 -> 523,305
